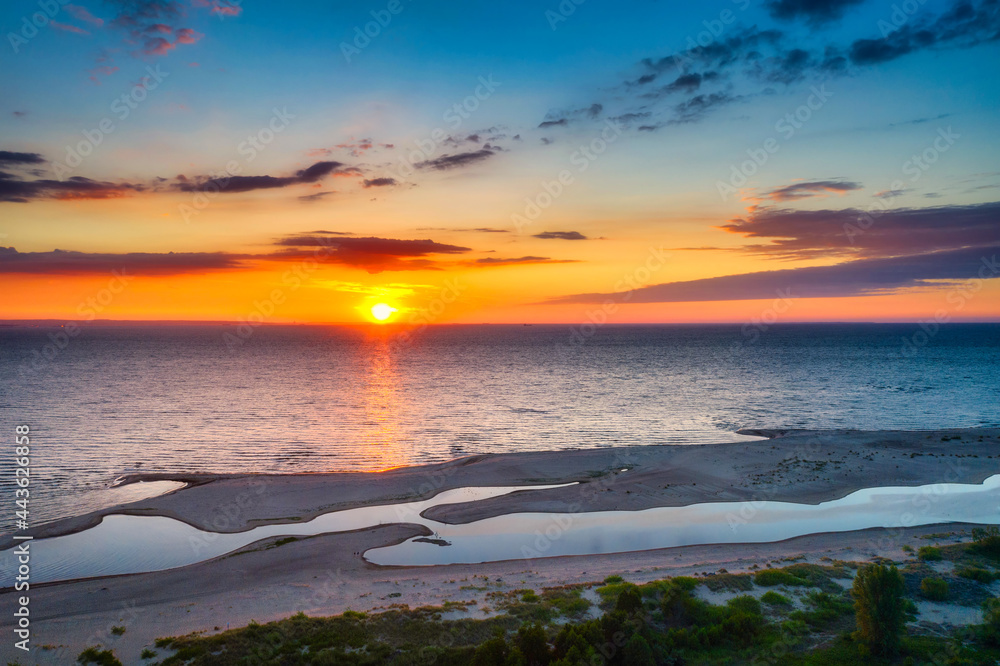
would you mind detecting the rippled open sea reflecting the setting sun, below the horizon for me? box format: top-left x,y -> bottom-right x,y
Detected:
0,324 -> 1000,526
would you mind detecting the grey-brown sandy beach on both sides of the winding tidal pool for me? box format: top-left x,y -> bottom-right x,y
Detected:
0,429 -> 1000,663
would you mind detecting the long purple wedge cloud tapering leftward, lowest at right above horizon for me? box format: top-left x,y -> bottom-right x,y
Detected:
546,245 -> 1000,304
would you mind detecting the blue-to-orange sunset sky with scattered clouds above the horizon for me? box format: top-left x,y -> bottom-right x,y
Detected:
0,0 -> 1000,324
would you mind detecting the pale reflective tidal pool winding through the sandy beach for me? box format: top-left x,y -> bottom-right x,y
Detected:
0,475 -> 1000,586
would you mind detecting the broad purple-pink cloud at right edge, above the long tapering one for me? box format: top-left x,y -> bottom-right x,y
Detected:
720,202 -> 1000,259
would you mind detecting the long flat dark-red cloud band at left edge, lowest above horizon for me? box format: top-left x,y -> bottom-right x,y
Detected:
0,247 -> 244,275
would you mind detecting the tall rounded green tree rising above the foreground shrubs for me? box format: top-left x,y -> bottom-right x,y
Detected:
851,564 -> 906,655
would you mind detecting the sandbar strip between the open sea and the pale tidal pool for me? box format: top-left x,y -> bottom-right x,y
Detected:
9,428 -> 1000,550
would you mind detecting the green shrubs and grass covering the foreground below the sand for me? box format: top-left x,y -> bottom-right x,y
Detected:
152,551 -> 1000,666
